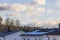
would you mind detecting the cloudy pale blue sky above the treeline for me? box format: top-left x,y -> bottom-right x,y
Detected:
0,0 -> 60,25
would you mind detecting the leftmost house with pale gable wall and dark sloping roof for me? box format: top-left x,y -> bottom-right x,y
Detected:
0,31 -> 24,40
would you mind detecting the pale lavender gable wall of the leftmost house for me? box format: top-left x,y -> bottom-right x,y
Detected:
5,31 -> 24,40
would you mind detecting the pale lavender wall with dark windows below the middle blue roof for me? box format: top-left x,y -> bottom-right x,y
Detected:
22,36 -> 48,40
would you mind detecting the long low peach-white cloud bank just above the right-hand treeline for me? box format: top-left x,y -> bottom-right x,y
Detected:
32,18 -> 60,25
